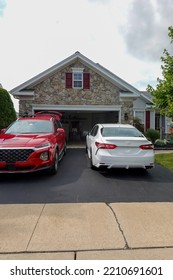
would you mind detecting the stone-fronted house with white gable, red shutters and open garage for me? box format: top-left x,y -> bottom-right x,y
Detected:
10,52 -> 169,140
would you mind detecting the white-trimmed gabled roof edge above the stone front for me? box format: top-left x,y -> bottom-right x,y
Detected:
10,51 -> 140,96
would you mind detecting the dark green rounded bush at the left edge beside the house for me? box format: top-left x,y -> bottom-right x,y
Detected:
0,88 -> 16,129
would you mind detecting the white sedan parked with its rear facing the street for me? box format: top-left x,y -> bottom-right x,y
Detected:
86,124 -> 154,169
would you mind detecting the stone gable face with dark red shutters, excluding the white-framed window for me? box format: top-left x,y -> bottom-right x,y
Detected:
31,61 -> 120,105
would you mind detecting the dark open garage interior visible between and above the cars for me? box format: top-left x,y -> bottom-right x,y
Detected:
61,111 -> 119,144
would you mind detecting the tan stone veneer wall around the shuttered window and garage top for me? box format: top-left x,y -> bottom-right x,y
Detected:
19,63 -> 133,122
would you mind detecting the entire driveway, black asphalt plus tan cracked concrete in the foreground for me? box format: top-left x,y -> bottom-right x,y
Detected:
0,149 -> 173,260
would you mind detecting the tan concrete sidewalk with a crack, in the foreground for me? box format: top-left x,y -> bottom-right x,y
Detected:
0,203 -> 173,260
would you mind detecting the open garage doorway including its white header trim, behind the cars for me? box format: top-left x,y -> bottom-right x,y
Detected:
32,105 -> 121,144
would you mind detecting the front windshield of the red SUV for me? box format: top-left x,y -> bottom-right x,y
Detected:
5,120 -> 53,134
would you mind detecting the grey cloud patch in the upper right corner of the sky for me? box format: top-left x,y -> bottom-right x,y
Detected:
120,0 -> 173,62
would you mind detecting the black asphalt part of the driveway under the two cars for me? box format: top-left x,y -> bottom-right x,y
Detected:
0,148 -> 173,204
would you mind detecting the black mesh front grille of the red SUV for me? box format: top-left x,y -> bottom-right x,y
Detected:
0,149 -> 34,162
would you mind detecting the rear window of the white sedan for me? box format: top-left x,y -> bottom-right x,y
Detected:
101,127 -> 144,137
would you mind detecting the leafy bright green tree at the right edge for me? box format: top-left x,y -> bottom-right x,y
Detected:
147,26 -> 173,118
